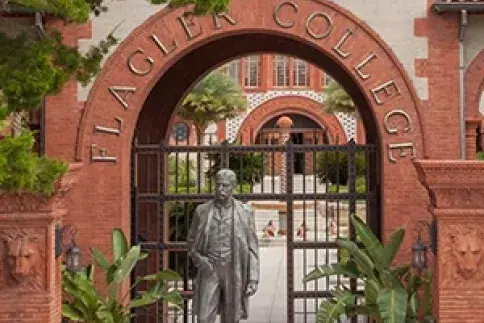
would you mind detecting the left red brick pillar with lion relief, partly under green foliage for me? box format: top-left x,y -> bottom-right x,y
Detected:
0,164 -> 81,323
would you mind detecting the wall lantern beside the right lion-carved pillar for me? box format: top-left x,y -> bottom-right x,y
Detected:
412,219 -> 437,270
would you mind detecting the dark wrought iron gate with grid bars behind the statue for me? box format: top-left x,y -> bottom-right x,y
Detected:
132,141 -> 379,323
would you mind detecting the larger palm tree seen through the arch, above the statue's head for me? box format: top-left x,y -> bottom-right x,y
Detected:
178,71 -> 247,143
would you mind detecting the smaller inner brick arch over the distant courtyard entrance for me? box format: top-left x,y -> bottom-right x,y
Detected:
237,96 -> 347,144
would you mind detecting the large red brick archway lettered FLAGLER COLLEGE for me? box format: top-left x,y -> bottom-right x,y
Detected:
46,0 -> 428,256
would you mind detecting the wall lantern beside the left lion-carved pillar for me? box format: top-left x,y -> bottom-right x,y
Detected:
55,224 -> 82,272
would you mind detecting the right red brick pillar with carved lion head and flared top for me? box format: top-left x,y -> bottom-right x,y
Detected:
415,160 -> 484,323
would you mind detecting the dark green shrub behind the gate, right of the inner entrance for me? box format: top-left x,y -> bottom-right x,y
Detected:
316,151 -> 366,185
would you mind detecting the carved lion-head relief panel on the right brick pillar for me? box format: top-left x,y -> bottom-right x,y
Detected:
439,224 -> 484,288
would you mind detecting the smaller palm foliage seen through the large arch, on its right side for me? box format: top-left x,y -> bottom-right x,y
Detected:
324,80 -> 358,116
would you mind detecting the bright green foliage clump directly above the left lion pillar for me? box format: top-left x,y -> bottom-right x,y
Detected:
0,132 -> 67,195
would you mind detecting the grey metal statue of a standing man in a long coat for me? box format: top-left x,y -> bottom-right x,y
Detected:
187,169 -> 259,323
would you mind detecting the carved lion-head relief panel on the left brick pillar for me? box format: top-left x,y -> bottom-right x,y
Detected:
0,228 -> 46,291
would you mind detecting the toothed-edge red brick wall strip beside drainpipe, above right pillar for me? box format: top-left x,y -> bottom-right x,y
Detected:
415,0 -> 460,159
